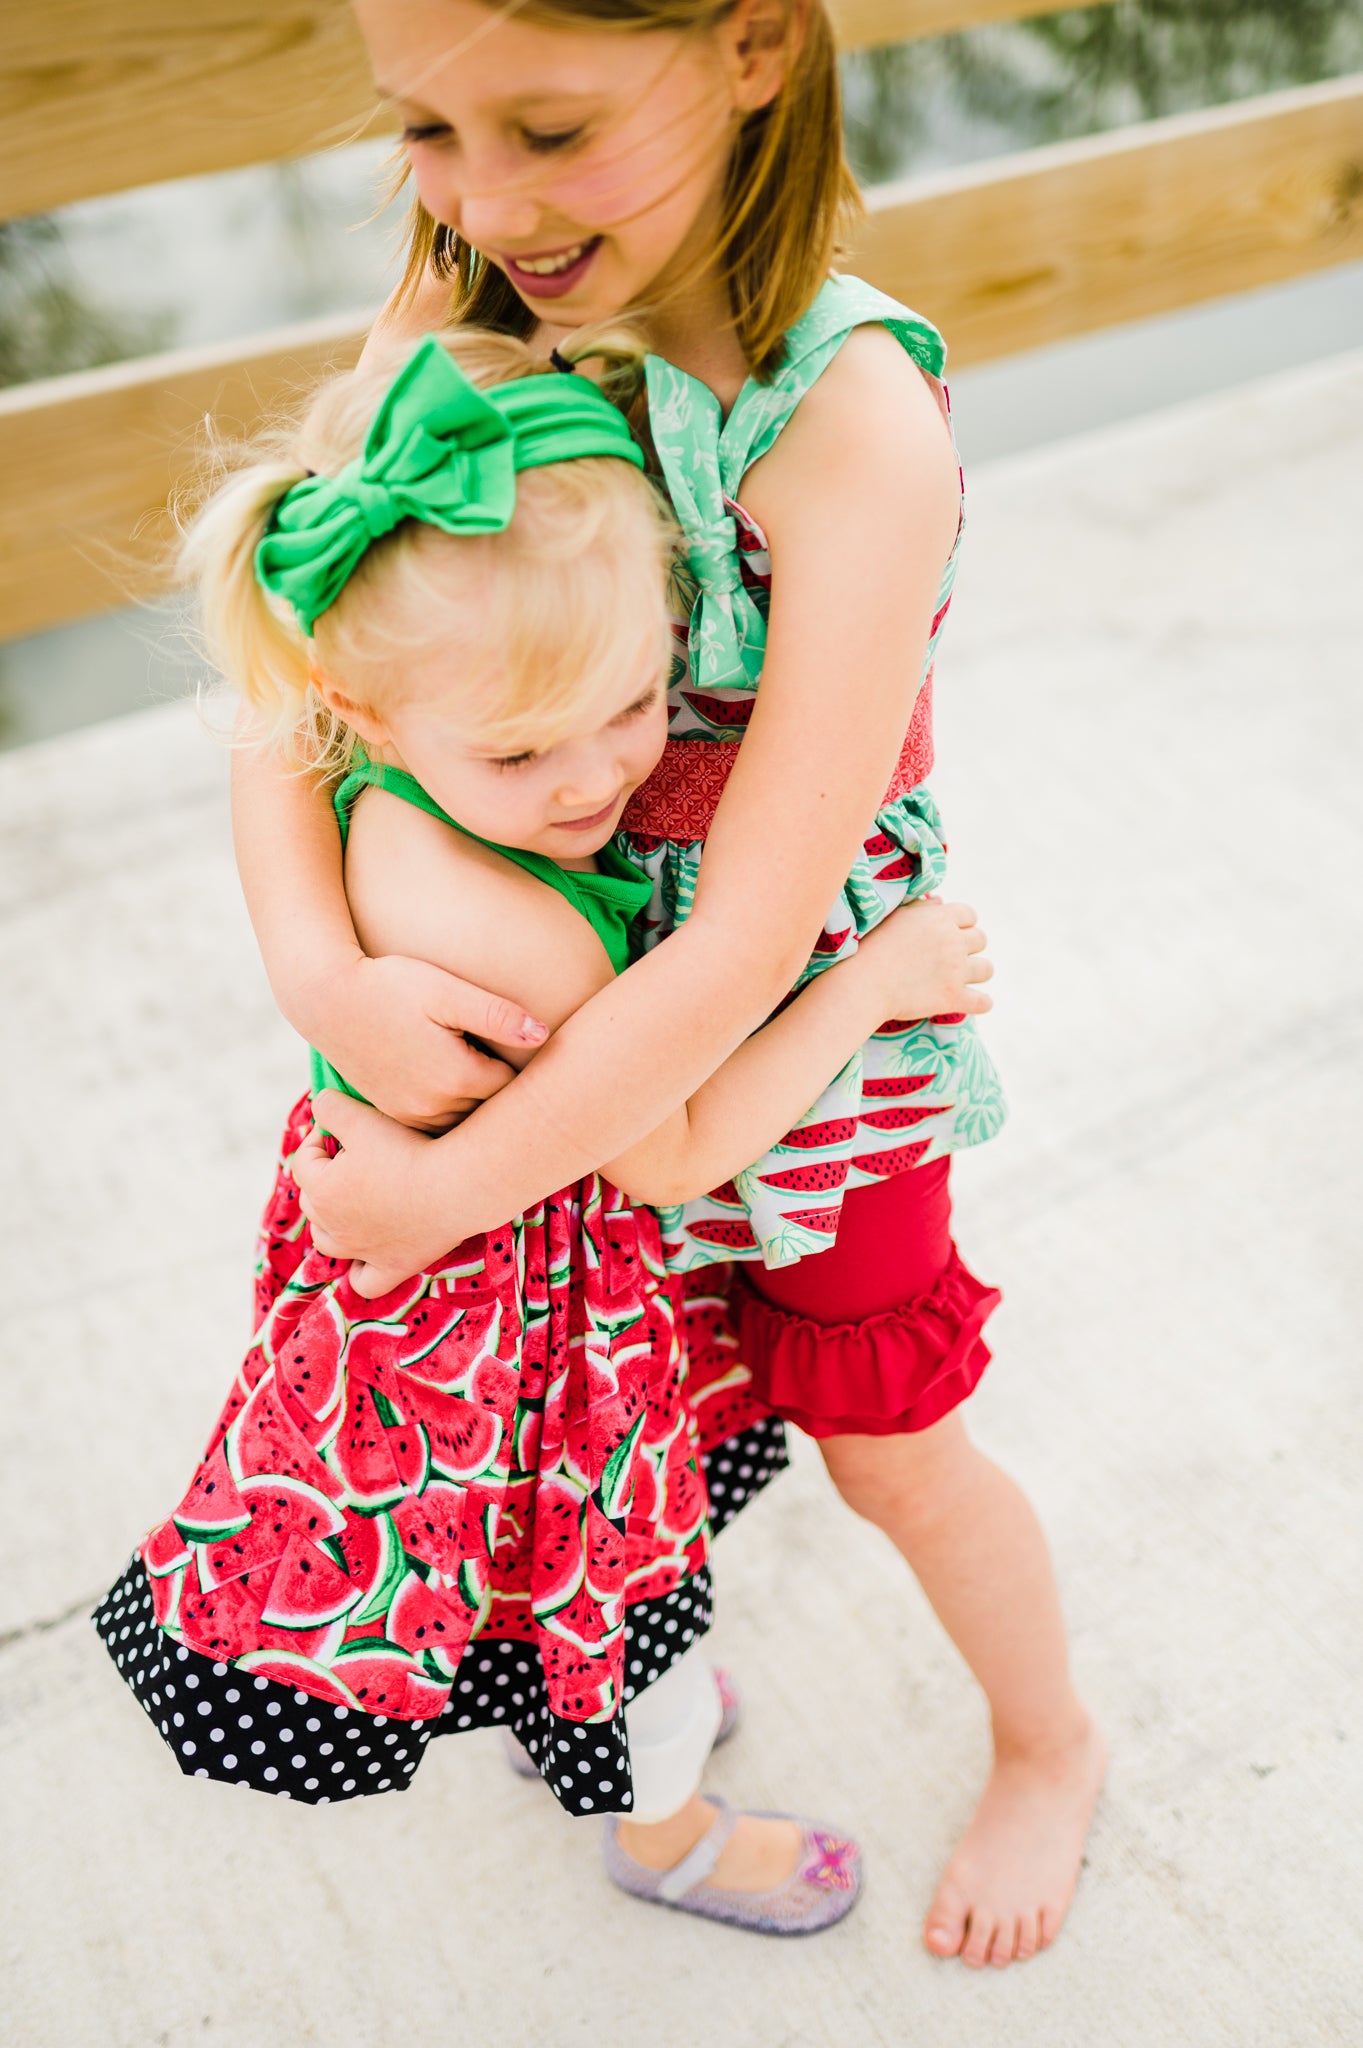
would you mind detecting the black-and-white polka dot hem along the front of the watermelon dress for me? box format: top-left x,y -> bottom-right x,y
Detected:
94,1556 -> 712,1815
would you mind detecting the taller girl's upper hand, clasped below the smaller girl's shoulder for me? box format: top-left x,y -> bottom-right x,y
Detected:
306,954 -> 548,1130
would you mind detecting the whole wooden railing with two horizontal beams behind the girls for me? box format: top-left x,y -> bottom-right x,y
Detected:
0,0 -> 1363,639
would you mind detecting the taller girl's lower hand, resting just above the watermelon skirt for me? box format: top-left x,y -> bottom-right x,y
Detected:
293,1087 -> 450,1296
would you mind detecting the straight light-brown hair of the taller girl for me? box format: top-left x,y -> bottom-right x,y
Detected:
399,0 -> 862,379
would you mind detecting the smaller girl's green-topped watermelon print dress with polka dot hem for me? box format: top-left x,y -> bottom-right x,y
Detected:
94,764 -> 786,1812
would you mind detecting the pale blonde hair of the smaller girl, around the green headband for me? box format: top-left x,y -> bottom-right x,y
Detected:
178,328 -> 675,774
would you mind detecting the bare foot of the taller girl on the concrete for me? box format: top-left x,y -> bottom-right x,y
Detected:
923,1714 -> 1107,1970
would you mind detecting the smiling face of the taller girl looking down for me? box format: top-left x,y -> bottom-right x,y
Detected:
356,0 -> 784,328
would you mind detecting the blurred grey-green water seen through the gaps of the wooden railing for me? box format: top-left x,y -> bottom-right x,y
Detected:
0,0 -> 1363,745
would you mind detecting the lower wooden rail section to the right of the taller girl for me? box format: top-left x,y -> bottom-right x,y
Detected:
847,74 -> 1363,369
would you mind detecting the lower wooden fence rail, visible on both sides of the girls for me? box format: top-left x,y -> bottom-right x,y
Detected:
0,78 -> 1363,639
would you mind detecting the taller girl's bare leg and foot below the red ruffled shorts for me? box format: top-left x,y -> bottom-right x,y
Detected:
819,1413 -> 1103,1968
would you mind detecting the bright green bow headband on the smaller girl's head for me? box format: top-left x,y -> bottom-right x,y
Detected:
256,334 -> 643,637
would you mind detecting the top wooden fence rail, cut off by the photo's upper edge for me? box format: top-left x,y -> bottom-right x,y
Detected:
0,0 -> 1113,219
